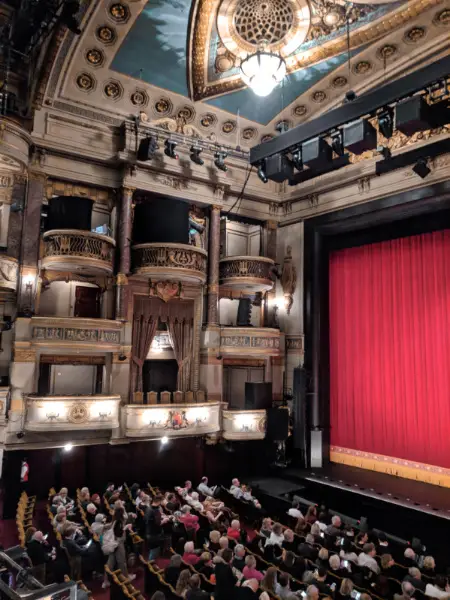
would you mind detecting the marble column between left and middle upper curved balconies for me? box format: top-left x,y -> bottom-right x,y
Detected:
116,186 -> 135,321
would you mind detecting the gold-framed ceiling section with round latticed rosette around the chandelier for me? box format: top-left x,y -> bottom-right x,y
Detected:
188,0 -> 408,101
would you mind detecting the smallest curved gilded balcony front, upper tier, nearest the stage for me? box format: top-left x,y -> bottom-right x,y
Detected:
219,256 -> 275,293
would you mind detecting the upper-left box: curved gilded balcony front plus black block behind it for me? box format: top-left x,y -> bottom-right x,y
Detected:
41,196 -> 116,275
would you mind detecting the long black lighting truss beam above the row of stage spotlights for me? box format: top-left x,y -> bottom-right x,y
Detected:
250,56 -> 450,165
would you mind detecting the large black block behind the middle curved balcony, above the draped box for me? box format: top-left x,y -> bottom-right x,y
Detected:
133,198 -> 189,244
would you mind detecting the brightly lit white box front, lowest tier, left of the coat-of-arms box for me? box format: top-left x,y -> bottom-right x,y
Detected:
25,394 -> 120,431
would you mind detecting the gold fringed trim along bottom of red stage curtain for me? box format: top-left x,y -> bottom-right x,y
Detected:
330,446 -> 450,488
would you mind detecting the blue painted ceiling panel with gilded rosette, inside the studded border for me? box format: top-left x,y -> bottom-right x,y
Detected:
111,0 -> 407,125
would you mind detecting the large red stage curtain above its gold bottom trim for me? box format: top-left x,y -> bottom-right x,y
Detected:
329,231 -> 450,467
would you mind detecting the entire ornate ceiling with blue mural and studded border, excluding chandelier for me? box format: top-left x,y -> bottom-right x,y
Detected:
40,0 -> 450,145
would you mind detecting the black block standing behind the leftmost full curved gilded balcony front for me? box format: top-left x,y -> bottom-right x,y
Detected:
45,196 -> 94,231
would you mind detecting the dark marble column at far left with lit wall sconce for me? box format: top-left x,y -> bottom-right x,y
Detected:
17,171 -> 47,312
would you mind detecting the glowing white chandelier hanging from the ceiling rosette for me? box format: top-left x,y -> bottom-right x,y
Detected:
241,48 -> 286,96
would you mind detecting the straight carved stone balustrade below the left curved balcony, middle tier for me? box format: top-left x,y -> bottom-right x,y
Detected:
30,317 -> 122,352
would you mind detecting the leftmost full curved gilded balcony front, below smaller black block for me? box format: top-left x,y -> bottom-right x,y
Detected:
41,229 -> 116,275
